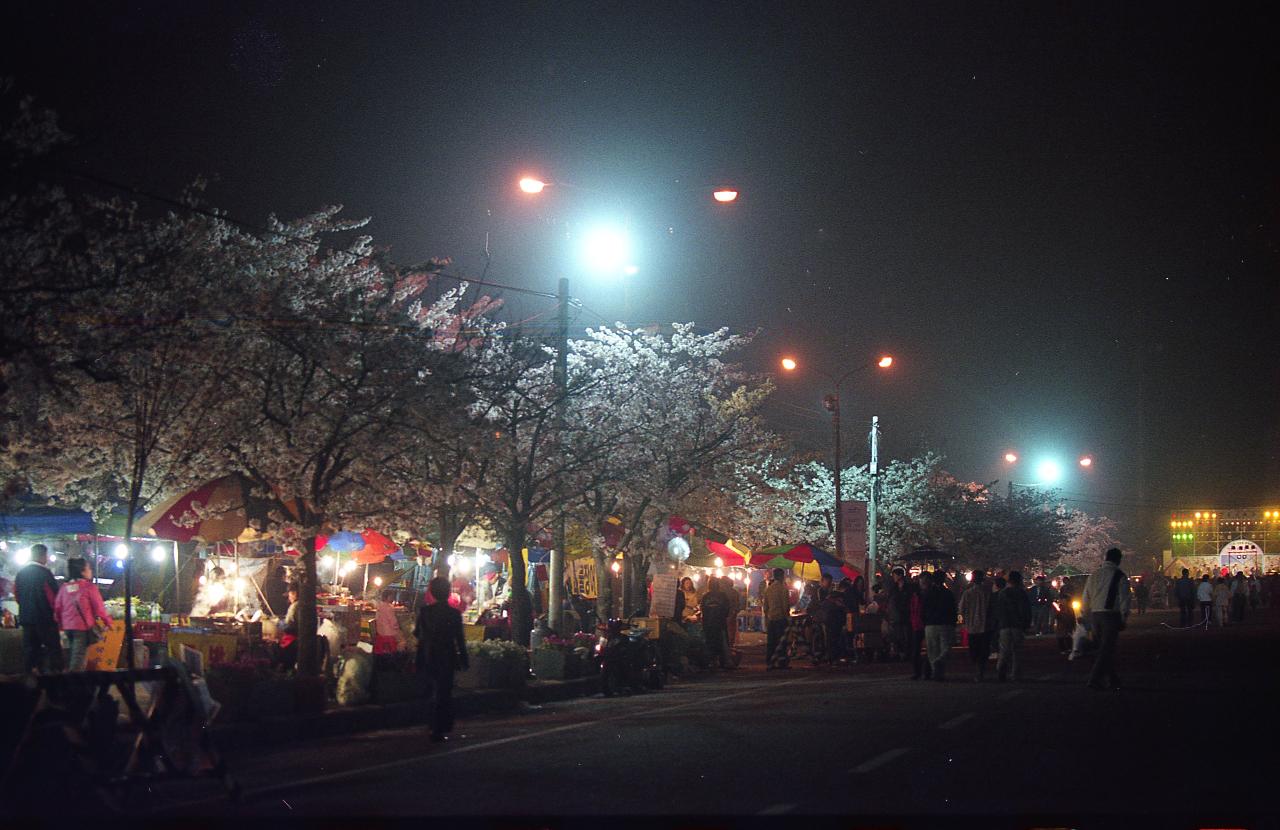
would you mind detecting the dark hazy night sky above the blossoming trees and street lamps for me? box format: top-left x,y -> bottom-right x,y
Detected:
0,0 -> 1280,546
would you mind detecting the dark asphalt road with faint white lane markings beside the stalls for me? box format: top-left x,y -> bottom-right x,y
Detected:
147,612 -> 1280,827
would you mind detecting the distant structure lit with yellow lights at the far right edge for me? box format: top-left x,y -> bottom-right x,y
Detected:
1164,507 -> 1280,576
